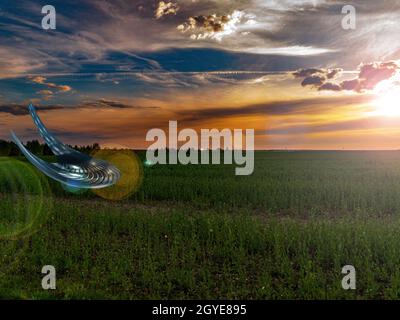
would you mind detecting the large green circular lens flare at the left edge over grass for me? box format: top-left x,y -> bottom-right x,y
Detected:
0,158 -> 53,271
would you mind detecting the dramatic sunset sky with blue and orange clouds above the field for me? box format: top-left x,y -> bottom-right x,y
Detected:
0,0 -> 400,150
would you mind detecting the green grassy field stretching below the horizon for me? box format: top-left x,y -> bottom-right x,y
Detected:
0,151 -> 400,299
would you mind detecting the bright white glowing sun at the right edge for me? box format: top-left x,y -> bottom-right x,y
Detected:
373,81 -> 400,117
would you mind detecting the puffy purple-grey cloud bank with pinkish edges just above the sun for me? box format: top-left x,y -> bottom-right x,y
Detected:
293,61 -> 400,92
